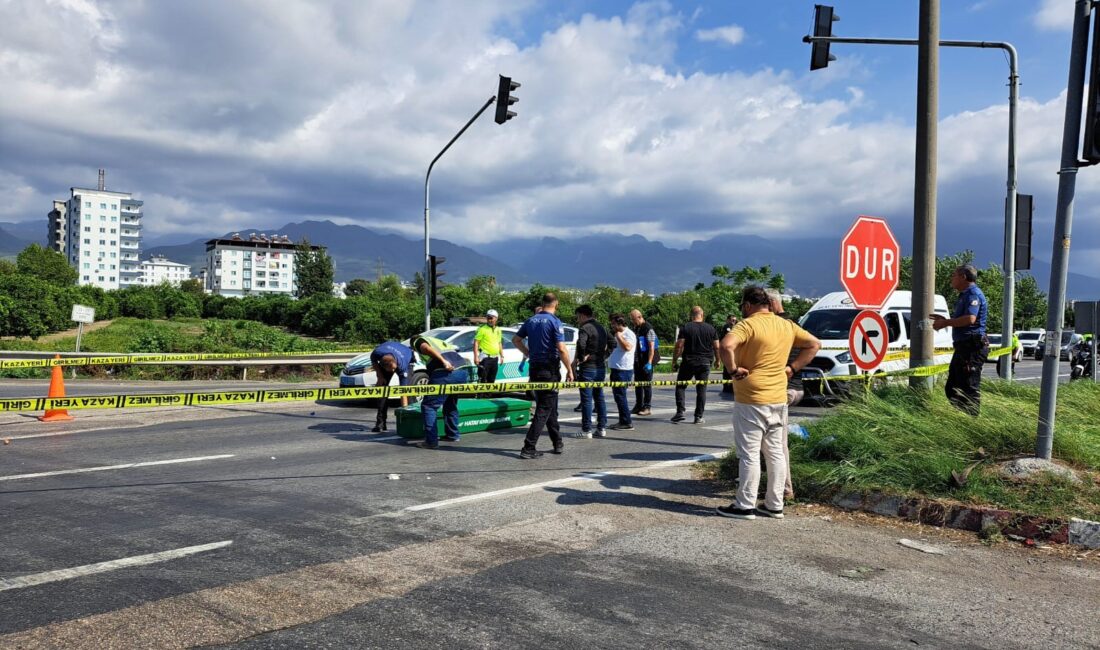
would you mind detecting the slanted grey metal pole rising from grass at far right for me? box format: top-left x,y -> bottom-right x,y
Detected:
1035,0 -> 1092,460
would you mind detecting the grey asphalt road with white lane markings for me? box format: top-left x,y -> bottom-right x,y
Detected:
0,373 -> 1100,648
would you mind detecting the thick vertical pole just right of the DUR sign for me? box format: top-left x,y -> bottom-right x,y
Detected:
909,0 -> 939,390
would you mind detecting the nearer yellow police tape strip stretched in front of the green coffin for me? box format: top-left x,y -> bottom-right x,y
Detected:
0,348 -> 1011,412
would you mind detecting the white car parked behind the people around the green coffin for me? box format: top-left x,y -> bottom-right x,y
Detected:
340,326 -> 576,386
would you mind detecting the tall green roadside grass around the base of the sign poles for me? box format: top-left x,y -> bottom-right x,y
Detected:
716,381 -> 1100,520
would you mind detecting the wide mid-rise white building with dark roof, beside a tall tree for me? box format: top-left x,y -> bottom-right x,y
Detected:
206,233 -> 321,297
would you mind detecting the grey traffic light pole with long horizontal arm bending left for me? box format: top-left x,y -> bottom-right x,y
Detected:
802,36 -> 1020,379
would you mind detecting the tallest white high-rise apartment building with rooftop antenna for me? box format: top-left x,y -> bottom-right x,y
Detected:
48,169 -> 143,289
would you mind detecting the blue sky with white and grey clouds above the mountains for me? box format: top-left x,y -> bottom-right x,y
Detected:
0,0 -> 1100,275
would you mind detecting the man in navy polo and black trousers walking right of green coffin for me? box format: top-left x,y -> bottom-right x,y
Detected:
512,291 -> 573,459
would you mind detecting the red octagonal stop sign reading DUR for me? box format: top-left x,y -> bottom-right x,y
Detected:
840,216 -> 901,309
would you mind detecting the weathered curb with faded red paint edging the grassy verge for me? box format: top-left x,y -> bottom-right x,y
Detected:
821,493 -> 1100,549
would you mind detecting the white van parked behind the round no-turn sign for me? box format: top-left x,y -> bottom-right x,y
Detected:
799,291 -> 952,396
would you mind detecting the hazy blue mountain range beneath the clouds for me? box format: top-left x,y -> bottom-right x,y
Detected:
0,221 -> 1100,299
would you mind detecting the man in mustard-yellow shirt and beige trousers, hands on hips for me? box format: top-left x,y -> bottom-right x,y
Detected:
717,286 -> 822,519
